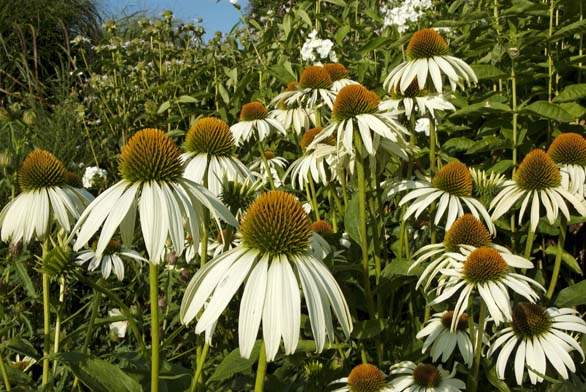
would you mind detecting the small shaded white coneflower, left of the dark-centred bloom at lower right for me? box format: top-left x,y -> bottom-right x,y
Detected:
416,310 -> 474,367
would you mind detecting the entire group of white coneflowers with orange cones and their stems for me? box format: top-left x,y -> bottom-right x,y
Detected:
0,29 -> 586,392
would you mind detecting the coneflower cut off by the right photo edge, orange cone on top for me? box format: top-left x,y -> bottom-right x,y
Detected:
547,133 -> 586,199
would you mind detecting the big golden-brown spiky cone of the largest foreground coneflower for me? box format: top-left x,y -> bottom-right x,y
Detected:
240,191 -> 311,255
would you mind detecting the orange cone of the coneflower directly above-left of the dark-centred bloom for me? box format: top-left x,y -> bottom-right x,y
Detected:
464,247 -> 509,283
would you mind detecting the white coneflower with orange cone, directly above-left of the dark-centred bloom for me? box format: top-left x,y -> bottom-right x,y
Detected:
429,247 -> 545,330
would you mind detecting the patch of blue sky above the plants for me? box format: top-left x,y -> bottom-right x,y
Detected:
98,0 -> 246,37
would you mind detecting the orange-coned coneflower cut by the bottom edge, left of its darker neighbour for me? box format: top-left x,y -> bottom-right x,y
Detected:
330,363 -> 394,392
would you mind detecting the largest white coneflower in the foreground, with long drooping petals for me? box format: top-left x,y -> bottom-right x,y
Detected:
180,191 -> 352,361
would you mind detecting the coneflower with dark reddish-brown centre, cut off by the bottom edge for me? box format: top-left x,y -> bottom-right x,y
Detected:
389,361 -> 466,392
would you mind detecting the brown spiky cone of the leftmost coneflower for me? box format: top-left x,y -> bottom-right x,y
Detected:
18,149 -> 66,191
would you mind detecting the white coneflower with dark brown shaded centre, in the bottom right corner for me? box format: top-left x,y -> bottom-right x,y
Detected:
488,303 -> 586,385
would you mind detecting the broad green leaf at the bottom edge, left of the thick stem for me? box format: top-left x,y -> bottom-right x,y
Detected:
55,352 -> 142,392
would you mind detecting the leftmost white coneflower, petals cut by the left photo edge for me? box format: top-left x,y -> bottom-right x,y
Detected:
0,149 -> 91,245
